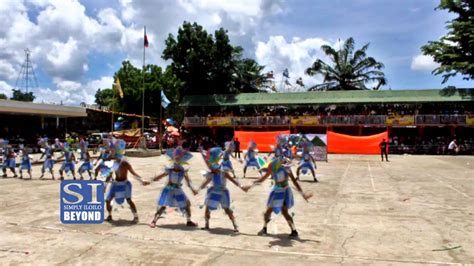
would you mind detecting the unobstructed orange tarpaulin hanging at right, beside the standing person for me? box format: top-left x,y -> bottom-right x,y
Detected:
327,131 -> 388,154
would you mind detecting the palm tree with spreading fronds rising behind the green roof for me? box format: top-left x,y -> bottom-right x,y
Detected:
306,37 -> 387,91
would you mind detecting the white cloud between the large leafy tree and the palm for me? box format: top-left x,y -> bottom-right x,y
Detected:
255,36 -> 329,89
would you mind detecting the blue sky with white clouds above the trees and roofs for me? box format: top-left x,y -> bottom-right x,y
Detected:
0,0 -> 474,105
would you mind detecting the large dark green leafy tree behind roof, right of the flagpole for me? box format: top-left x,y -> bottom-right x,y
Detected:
163,22 -> 264,95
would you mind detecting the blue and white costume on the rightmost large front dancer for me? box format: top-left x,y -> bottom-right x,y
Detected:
267,167 -> 295,214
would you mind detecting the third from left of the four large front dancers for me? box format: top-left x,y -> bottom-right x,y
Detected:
194,147 -> 243,232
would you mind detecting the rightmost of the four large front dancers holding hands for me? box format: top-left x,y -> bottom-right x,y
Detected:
244,158 -> 312,237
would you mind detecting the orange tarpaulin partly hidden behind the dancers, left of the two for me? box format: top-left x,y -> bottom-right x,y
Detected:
234,130 -> 290,152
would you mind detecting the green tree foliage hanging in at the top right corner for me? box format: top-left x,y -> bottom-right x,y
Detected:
421,0 -> 474,83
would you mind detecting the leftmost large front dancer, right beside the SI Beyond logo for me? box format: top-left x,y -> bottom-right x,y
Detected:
105,139 -> 148,223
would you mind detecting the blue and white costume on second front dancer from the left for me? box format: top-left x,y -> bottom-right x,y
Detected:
157,166 -> 188,212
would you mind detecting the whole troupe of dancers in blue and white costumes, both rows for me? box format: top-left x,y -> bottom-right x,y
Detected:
2,136 -> 316,237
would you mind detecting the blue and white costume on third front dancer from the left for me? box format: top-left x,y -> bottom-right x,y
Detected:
205,171 -> 230,210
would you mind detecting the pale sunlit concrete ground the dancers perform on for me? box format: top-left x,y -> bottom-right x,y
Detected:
0,155 -> 474,265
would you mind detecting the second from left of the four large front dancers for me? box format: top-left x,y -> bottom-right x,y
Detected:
150,146 -> 197,228
